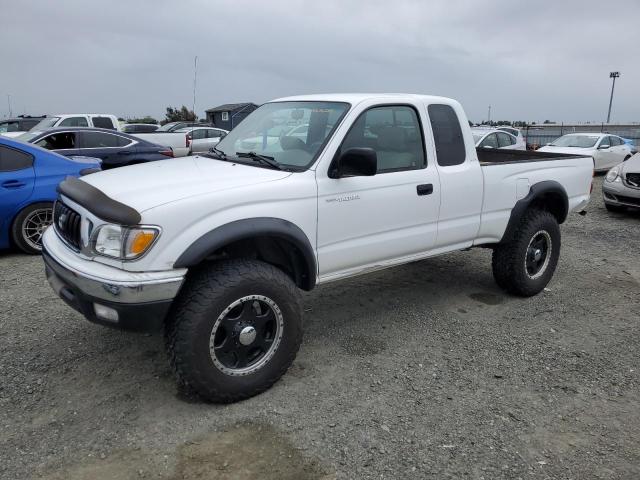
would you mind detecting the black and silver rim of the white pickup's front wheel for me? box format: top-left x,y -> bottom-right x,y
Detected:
209,295 -> 284,376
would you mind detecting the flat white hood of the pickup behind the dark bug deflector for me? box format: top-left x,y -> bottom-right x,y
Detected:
82,156 -> 291,212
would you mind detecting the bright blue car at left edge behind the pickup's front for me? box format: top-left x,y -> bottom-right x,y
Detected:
0,137 -> 100,254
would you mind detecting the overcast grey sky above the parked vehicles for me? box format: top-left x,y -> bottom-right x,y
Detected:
0,0 -> 640,122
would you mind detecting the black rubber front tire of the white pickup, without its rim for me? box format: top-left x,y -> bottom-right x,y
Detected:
165,260 -> 303,403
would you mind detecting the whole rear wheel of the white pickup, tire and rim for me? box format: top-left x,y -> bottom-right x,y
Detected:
491,210 -> 560,297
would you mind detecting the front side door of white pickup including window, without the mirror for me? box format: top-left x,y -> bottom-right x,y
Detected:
317,105 -> 440,280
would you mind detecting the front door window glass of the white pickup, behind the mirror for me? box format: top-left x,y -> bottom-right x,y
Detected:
340,105 -> 426,173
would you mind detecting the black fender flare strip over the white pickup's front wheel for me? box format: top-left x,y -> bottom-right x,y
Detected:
173,217 -> 318,290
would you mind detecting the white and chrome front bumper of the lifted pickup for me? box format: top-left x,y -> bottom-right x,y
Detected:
42,229 -> 184,332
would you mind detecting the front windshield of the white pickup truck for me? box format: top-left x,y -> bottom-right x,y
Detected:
216,102 -> 349,170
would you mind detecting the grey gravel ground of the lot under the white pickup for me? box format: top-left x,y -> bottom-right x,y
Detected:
0,177 -> 640,480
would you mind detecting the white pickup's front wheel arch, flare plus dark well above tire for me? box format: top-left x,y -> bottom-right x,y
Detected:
173,217 -> 317,290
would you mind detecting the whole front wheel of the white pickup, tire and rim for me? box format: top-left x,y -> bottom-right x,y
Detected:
165,260 -> 303,403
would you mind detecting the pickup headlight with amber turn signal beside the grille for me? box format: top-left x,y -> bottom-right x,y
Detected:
91,224 -> 160,260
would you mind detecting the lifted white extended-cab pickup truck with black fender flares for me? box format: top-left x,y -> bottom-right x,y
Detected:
43,94 -> 593,402
